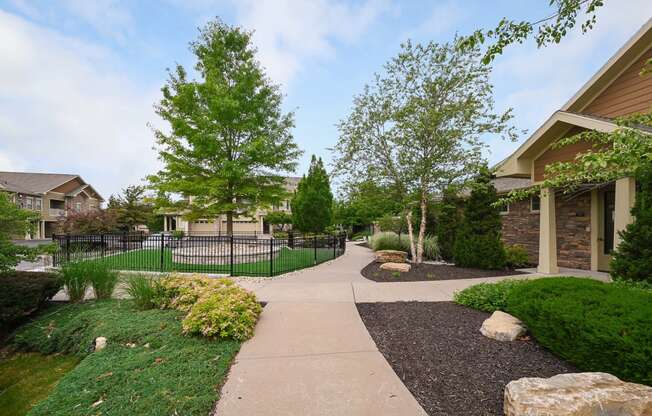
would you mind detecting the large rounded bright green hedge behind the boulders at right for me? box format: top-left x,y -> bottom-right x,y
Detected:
507,278 -> 652,385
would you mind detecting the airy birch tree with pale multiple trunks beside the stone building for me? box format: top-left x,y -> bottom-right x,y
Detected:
335,39 -> 516,263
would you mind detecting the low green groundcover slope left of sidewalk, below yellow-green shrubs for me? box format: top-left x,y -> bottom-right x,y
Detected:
14,300 -> 240,416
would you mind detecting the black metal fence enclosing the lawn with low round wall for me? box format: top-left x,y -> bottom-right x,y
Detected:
52,233 -> 346,276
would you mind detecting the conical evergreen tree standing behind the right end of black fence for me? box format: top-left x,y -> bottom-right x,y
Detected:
292,155 -> 333,233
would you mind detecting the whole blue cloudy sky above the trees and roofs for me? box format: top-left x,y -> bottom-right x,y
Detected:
0,0 -> 652,197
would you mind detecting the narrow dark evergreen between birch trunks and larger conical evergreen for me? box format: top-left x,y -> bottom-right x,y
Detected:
436,187 -> 464,262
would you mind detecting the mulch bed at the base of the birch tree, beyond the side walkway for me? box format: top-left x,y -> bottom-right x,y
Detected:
360,261 -> 526,282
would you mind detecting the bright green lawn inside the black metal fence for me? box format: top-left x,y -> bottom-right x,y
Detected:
77,247 -> 333,276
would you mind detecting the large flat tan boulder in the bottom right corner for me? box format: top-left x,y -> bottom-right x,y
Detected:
504,373 -> 652,416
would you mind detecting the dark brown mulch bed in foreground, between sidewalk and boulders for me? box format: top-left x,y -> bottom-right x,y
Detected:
357,302 -> 577,416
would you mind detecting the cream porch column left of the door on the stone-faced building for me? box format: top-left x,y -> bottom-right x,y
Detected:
537,188 -> 559,274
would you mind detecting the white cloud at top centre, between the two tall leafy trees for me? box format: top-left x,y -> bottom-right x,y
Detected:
230,0 -> 389,85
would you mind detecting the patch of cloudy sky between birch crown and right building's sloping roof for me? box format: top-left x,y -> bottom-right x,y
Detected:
490,0 -> 652,163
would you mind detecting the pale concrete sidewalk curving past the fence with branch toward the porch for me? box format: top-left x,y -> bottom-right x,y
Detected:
214,243 -> 608,416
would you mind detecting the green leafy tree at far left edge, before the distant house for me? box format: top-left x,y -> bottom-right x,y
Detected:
0,191 -> 39,273
